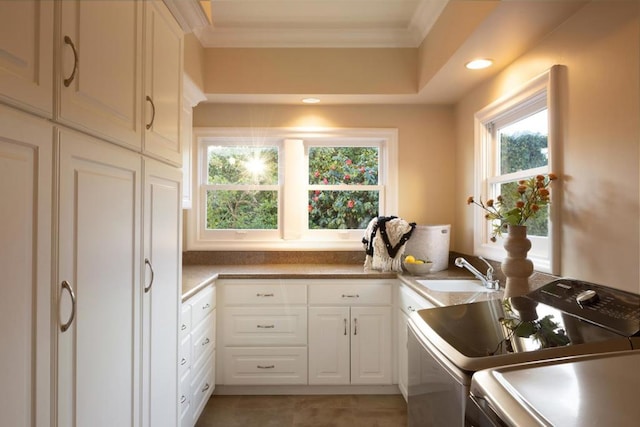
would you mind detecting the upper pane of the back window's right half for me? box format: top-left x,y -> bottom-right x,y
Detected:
309,147 -> 379,185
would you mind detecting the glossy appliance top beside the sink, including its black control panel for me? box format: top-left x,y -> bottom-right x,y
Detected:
412,279 -> 640,371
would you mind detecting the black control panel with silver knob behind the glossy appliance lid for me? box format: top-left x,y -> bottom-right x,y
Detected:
526,279 -> 640,337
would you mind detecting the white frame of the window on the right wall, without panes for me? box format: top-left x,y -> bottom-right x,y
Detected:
473,66 -> 561,274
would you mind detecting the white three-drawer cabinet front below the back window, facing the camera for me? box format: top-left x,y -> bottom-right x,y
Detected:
218,279 -> 307,385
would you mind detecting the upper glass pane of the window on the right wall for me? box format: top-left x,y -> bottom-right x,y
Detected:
498,109 -> 549,174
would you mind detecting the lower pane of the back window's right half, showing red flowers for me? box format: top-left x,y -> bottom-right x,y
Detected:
308,190 -> 380,230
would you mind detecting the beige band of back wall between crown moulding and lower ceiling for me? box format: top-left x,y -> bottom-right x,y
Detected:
205,48 -> 418,94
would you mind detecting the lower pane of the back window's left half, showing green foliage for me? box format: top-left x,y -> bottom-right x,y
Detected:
207,190 -> 278,230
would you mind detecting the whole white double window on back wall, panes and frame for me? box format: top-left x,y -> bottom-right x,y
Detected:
187,129 -> 397,250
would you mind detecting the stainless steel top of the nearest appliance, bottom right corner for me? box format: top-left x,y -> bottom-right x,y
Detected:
471,351 -> 640,427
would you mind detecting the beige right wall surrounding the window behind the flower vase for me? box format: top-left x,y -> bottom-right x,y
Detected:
453,2 -> 640,293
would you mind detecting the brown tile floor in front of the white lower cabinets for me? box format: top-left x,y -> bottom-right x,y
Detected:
196,394 -> 407,427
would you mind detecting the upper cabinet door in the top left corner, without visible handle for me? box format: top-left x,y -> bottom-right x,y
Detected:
0,0 -> 53,118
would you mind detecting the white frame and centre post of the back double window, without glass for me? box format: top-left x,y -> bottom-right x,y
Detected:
186,128 -> 398,250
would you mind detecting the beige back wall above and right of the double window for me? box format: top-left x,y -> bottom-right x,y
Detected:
194,104 -> 456,231
